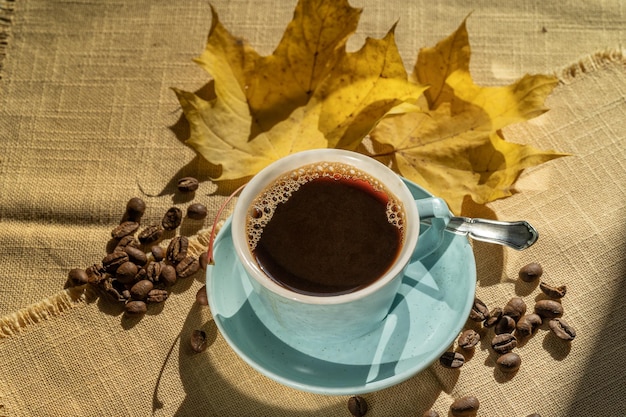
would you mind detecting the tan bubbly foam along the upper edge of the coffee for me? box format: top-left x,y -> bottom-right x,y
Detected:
246,162 -> 405,250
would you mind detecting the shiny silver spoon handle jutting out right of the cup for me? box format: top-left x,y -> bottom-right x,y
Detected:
446,217 -> 539,250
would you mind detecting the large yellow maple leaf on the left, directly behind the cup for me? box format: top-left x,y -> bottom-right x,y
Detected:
174,0 -> 424,180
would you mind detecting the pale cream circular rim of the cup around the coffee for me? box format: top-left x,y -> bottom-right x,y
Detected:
231,148 -> 420,305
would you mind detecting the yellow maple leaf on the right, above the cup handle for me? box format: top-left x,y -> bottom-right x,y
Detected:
371,21 -> 565,214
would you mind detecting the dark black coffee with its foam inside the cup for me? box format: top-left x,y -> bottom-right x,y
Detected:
247,164 -> 404,296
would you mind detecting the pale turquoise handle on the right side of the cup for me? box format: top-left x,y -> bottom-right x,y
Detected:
411,197 -> 452,262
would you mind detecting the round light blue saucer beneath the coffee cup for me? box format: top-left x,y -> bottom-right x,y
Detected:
207,181 -> 476,395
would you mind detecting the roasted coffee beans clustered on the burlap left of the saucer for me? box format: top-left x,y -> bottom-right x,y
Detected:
68,177 -> 207,318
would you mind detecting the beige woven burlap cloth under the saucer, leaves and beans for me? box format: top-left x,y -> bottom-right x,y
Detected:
0,0 -> 626,417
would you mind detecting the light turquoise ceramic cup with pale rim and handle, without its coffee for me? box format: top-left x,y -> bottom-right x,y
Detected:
232,149 -> 451,344
